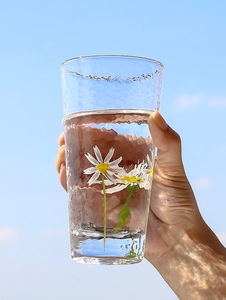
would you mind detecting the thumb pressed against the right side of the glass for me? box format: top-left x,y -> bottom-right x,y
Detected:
149,111 -> 183,172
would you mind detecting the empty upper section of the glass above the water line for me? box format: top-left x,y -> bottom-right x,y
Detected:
62,55 -> 164,115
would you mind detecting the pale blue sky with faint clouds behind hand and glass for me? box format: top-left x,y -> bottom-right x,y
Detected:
0,0 -> 226,300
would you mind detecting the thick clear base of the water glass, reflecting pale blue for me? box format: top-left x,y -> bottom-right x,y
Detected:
71,227 -> 145,265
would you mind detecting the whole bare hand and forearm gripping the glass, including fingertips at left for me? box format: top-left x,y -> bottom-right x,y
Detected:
56,112 -> 226,300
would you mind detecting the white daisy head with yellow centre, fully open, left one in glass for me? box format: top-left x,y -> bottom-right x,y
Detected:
84,146 -> 122,185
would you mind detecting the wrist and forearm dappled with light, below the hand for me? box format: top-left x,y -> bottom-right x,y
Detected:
156,219 -> 226,300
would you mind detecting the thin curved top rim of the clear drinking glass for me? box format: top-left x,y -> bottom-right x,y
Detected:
61,54 -> 164,68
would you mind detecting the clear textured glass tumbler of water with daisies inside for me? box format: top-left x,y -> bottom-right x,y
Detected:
61,55 -> 164,264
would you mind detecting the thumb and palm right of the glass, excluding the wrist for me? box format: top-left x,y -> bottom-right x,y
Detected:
145,112 -> 203,269
